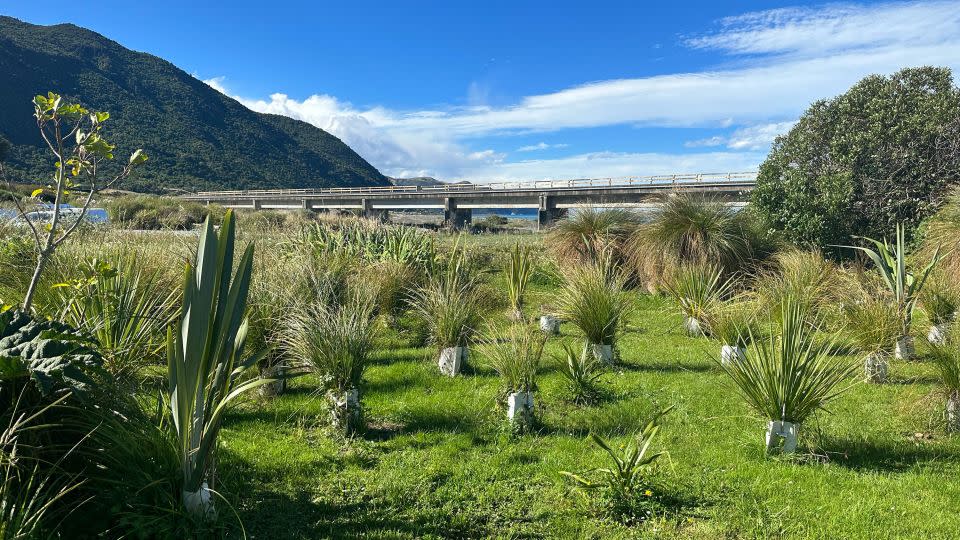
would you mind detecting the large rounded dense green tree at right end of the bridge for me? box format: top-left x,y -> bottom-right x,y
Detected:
753,67 -> 960,246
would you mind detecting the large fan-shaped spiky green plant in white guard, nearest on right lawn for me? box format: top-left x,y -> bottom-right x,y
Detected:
721,298 -> 857,453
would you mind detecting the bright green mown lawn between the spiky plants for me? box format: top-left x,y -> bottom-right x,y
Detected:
218,276 -> 960,539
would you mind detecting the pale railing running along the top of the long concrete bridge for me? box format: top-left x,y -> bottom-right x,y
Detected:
186,172 -> 757,199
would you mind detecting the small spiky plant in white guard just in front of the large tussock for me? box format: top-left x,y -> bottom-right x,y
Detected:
667,264 -> 733,336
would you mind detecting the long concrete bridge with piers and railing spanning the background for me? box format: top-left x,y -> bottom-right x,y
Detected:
183,172 -> 757,228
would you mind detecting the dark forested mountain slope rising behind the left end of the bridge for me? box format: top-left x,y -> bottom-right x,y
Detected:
0,16 -> 390,193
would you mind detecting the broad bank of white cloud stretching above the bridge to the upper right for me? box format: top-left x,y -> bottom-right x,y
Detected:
207,2 -> 960,179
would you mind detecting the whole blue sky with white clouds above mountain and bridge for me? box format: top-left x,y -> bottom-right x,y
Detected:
0,0 -> 960,181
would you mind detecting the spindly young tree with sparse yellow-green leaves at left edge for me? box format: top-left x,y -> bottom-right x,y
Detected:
0,92 -> 147,311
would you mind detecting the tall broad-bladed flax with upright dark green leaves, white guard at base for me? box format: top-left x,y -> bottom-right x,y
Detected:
167,210 -> 270,519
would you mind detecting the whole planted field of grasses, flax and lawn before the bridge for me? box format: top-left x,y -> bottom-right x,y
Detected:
0,69 -> 960,539
